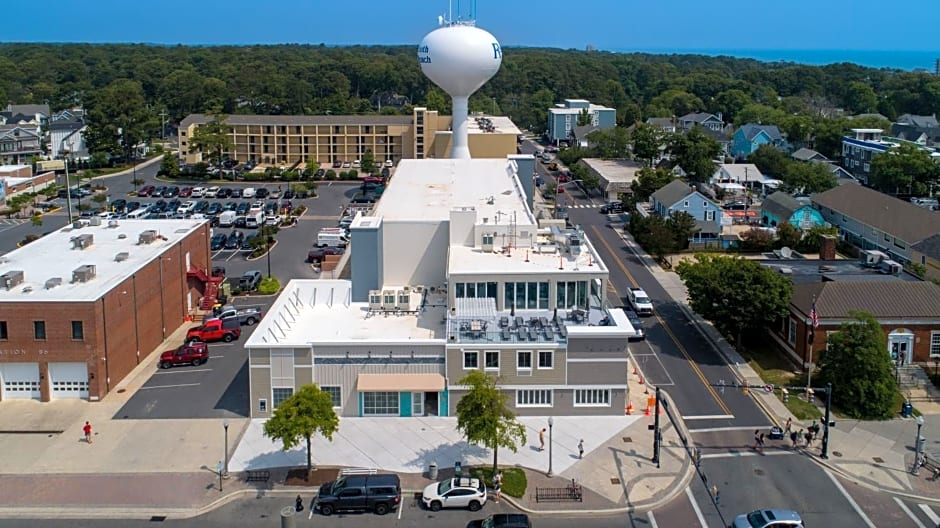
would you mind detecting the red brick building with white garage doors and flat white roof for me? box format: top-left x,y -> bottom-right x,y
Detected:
0,218 -> 210,401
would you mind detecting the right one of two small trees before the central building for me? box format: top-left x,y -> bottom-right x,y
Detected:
457,370 -> 526,472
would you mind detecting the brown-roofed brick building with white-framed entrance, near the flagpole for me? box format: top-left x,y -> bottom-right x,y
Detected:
771,280 -> 940,368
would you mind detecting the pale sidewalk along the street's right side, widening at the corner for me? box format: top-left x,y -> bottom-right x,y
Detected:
621,226 -> 940,503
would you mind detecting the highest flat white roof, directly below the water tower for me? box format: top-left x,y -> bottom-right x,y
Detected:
372,158 -> 535,225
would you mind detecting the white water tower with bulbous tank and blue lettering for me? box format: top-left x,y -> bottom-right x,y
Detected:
418,2 -> 503,158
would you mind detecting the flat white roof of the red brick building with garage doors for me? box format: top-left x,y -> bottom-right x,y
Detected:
0,220 -> 205,303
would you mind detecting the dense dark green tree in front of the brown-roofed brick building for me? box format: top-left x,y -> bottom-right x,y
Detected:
819,312 -> 898,420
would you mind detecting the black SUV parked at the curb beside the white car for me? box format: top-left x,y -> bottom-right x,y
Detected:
313,475 -> 401,515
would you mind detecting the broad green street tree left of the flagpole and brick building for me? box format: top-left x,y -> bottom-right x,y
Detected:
676,254 -> 791,345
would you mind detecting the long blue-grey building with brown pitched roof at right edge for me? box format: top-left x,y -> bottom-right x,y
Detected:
811,185 -> 940,264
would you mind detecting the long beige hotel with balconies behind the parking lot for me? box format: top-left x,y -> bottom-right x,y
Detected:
179,107 -> 519,166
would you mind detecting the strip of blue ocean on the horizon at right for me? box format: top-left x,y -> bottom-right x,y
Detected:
610,48 -> 940,72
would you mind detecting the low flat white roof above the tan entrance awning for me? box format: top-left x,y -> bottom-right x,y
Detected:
245,278 -> 446,348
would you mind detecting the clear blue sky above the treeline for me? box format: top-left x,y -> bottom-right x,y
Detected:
0,0 -> 940,51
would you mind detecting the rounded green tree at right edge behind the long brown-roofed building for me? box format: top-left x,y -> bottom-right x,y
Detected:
869,143 -> 940,195
